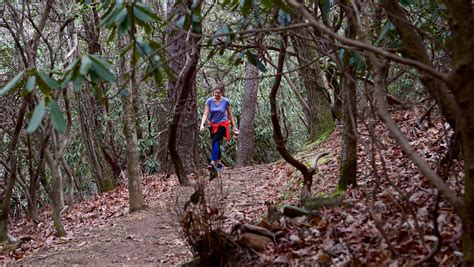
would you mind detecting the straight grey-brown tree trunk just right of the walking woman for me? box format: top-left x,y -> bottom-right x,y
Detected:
237,63 -> 258,167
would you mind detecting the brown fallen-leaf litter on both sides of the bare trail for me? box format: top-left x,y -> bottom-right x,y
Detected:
0,106 -> 463,265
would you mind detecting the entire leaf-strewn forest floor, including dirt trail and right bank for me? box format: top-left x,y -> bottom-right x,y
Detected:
0,109 -> 463,266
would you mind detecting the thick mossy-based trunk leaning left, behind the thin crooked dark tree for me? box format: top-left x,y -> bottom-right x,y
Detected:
291,12 -> 335,141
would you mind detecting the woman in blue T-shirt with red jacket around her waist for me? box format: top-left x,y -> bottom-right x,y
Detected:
199,83 -> 239,177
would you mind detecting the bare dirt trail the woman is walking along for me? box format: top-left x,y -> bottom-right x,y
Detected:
16,165 -> 282,266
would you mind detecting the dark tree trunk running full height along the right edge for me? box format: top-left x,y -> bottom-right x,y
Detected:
445,1 -> 474,266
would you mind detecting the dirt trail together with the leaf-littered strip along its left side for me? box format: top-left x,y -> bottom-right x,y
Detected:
5,165 -> 290,266
